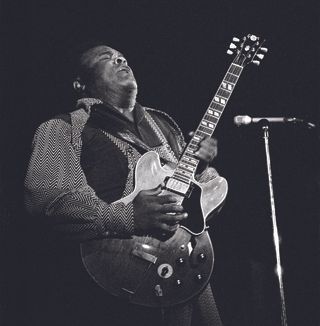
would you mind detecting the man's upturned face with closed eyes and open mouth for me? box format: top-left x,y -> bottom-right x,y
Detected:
81,45 -> 137,99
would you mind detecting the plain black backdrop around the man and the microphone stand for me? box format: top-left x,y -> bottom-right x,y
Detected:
0,0 -> 319,326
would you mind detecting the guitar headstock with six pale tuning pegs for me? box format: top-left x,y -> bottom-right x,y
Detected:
227,34 -> 268,67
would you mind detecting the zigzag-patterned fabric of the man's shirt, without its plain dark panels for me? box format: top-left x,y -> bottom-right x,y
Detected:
25,99 -> 217,241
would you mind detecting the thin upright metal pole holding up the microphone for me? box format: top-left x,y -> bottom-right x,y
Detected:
262,120 -> 287,326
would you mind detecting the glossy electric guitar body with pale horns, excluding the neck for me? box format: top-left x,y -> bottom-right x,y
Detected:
81,151 -> 227,307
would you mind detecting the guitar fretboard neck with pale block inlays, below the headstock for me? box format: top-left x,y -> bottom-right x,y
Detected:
173,63 -> 243,183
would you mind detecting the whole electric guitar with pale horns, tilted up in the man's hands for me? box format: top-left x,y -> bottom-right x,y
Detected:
81,34 -> 267,307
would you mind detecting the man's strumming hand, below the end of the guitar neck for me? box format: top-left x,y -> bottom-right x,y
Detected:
133,186 -> 188,232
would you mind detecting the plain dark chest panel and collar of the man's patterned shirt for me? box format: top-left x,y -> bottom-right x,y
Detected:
81,104 -> 184,202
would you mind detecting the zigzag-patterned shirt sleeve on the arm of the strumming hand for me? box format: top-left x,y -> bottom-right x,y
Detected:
25,119 -> 134,241
